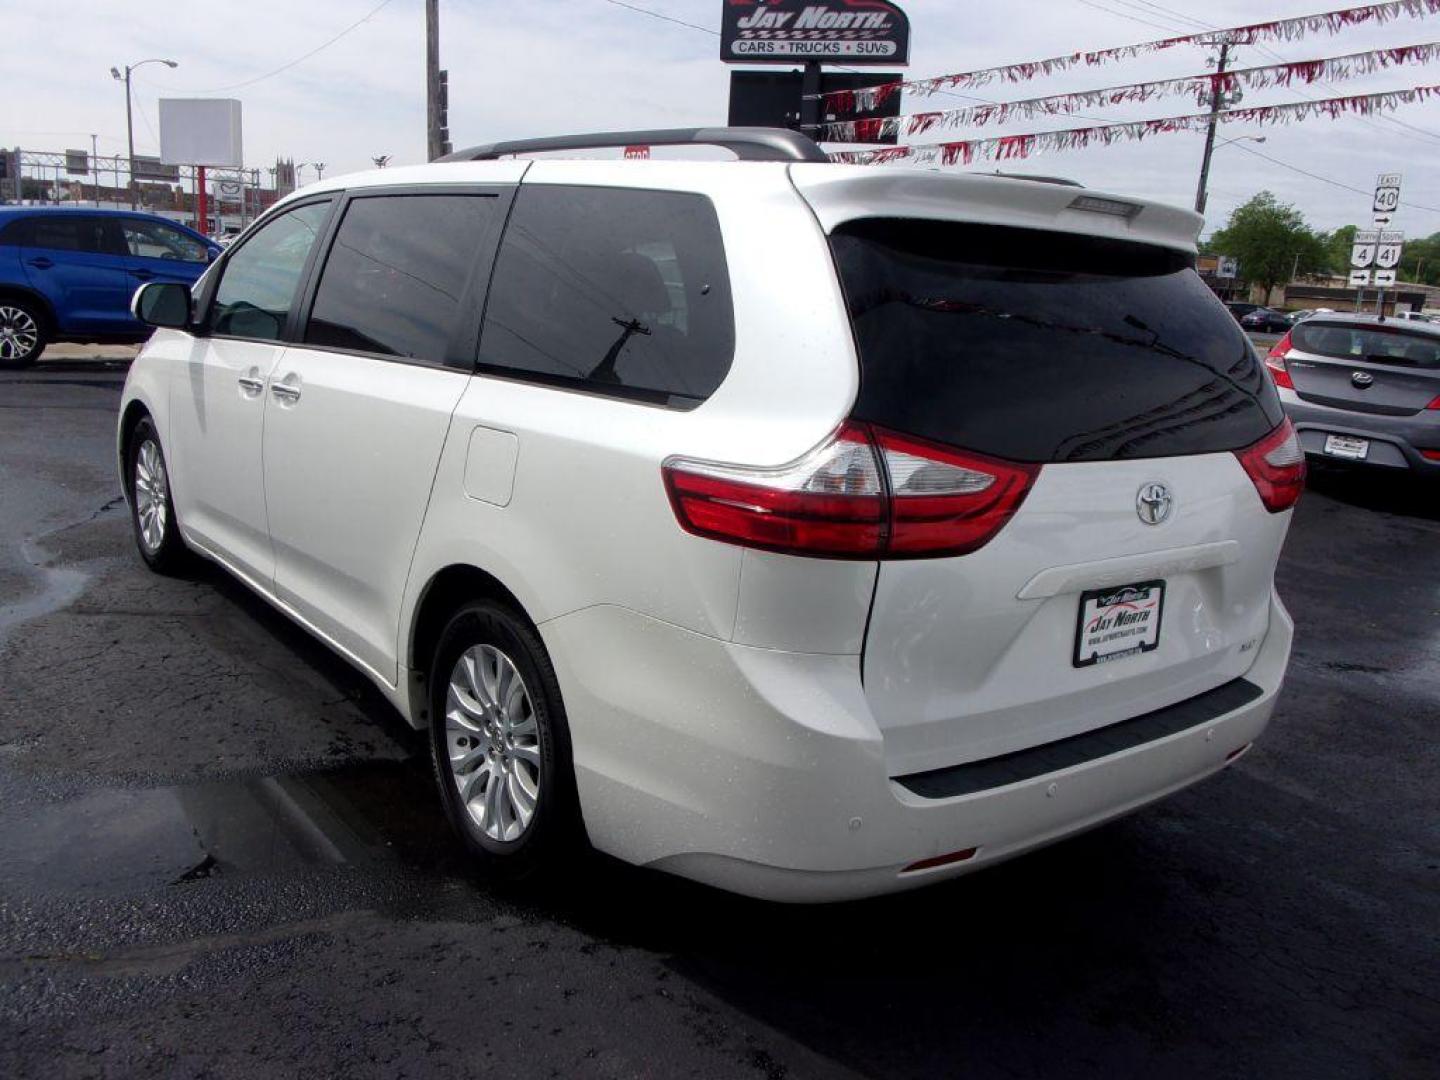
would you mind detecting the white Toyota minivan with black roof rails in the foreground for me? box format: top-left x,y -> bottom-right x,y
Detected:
117,130 -> 1305,900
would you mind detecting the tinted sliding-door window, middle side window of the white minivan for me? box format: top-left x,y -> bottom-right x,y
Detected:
305,194 -> 500,361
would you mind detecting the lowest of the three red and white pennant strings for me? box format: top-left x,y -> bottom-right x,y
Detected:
829,85 -> 1440,166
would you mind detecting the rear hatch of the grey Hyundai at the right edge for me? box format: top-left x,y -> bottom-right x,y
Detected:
1284,320 -> 1440,416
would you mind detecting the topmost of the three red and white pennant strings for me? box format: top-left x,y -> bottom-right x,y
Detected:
815,0 -> 1440,112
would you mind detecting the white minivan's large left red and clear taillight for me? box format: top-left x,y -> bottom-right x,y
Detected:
664,422 -> 1040,559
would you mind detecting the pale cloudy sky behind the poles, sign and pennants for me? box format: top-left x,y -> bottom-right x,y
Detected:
0,0 -> 1440,235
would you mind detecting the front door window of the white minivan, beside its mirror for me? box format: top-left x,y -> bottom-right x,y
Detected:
210,203 -> 330,341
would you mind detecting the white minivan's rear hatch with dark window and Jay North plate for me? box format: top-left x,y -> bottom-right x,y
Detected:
831,216 -> 1297,775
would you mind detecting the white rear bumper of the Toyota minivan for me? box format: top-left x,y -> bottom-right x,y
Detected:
541,598 -> 1293,901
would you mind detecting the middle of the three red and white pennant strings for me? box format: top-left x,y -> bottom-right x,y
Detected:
819,42 -> 1440,143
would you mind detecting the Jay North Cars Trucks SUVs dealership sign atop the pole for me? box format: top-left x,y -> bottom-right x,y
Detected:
720,0 -> 910,65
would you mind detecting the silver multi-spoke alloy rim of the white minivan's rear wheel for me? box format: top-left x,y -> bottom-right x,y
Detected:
445,645 -> 543,841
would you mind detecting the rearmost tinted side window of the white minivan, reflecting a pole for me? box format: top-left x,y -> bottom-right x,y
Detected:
480,184 -> 734,405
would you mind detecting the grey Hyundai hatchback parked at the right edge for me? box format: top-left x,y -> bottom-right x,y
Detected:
1266,312 -> 1440,475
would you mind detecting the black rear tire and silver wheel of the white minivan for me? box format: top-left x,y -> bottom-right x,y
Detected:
429,600 -> 583,881
